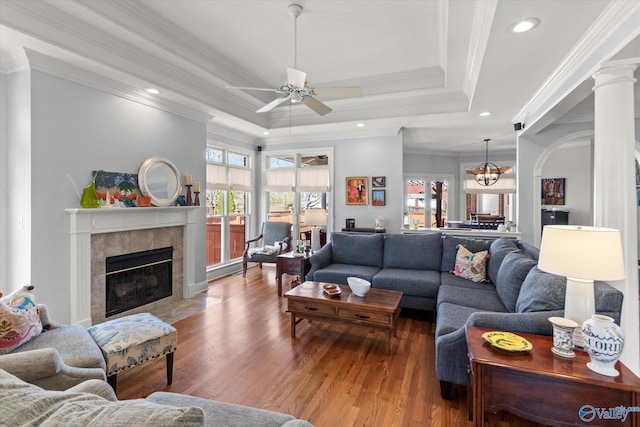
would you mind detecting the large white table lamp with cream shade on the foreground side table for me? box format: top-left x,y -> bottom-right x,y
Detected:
538,225 -> 624,348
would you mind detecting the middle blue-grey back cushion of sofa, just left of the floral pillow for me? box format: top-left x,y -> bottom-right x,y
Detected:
383,233 -> 442,271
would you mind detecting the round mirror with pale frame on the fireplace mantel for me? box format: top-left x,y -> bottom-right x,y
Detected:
138,157 -> 182,206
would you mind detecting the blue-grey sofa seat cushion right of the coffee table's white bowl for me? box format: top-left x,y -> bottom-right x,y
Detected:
371,268 -> 440,298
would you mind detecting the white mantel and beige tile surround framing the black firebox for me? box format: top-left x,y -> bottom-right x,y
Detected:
66,207 -> 199,327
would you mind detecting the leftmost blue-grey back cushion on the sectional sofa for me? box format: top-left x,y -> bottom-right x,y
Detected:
331,233 -> 384,268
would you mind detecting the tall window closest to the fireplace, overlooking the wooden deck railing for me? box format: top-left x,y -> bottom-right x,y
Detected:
206,147 -> 251,267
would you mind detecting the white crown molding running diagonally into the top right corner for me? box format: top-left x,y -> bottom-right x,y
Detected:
512,0 -> 640,134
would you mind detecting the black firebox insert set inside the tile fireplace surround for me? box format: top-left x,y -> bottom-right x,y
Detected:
105,247 -> 173,317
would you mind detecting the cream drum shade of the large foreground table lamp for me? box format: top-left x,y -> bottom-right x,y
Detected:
538,225 -> 625,280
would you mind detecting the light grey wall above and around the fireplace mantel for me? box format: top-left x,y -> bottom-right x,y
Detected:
9,71 -> 206,322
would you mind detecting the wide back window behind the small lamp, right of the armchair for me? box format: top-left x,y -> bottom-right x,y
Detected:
265,153 -> 331,244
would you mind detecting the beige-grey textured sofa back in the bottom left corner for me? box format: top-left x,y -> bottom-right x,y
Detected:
0,370 -> 205,427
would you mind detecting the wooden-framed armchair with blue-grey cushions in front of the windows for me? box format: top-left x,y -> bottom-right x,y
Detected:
242,221 -> 291,277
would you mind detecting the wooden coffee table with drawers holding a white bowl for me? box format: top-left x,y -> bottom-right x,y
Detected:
284,282 -> 402,355
